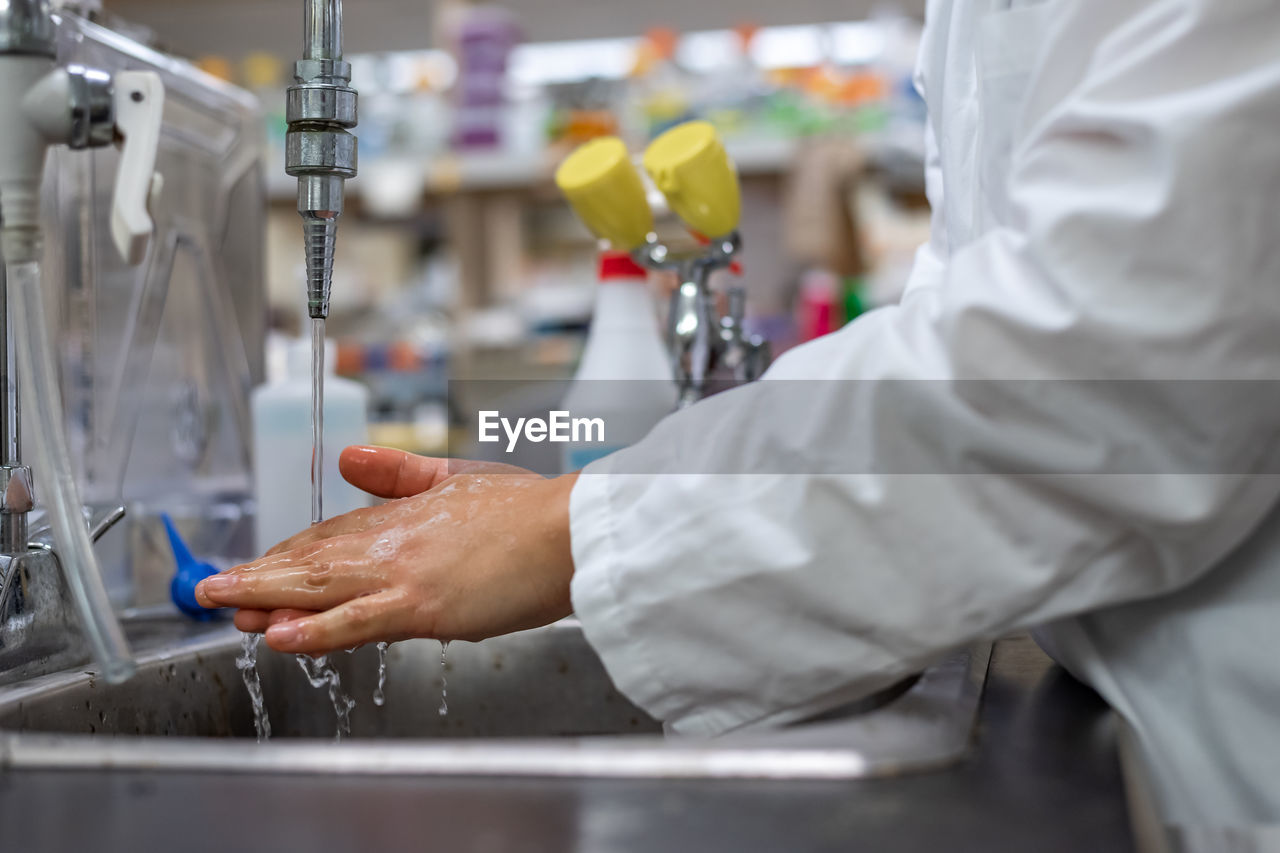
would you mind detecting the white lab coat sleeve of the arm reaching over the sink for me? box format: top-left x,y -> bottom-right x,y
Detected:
571,0 -> 1280,735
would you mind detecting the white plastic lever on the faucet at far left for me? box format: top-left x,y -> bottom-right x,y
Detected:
111,72 -> 164,264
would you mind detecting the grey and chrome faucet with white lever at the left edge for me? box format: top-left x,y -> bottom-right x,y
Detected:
0,0 -> 164,679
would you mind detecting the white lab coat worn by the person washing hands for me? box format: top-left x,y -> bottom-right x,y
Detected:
571,0 -> 1280,822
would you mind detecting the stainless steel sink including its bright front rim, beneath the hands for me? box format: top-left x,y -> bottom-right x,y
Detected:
0,620 -> 989,779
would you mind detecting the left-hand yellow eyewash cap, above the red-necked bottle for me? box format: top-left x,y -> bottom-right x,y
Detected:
556,136 -> 653,252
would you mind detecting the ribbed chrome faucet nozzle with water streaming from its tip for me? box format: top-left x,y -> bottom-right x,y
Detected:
284,0 -> 357,319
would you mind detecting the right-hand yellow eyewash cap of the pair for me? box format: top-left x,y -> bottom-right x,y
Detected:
644,122 -> 742,240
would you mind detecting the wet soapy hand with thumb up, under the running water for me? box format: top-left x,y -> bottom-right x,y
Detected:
196,447 -> 575,654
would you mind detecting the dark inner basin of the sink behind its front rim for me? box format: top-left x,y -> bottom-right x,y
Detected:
0,622 -> 662,740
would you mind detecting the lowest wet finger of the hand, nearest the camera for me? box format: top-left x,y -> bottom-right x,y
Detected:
266,590 -> 411,654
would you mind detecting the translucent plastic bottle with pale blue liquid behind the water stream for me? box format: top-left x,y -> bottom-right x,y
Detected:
252,341 -> 369,553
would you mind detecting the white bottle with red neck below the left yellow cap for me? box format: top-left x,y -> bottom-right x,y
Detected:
561,252 -> 677,473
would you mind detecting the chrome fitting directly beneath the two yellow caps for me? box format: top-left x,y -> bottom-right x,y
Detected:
635,231 -> 772,409
